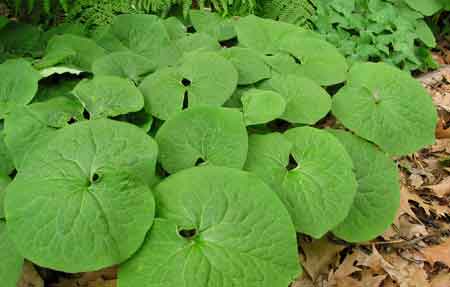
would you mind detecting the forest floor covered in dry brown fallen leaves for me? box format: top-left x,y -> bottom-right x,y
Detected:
14,35 -> 450,287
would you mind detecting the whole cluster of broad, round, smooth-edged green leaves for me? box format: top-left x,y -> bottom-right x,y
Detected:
0,11 -> 436,287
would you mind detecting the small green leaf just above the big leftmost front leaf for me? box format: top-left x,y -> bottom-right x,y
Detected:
73,76 -> 144,119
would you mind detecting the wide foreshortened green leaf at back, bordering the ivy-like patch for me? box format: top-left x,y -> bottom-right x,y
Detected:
236,16 -> 348,86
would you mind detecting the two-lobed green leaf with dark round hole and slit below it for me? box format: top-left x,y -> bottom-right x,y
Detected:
139,52 -> 238,120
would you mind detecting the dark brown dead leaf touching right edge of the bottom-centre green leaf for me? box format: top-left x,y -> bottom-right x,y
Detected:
300,237 -> 345,281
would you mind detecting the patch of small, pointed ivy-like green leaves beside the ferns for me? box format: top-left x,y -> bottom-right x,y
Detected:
310,0 -> 442,71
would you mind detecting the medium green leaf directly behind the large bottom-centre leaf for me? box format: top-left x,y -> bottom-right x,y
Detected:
156,107 -> 247,173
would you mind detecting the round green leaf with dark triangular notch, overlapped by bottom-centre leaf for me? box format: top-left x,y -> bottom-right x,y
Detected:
244,127 -> 357,238
